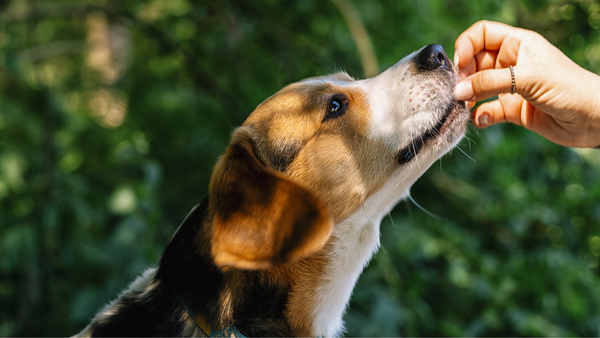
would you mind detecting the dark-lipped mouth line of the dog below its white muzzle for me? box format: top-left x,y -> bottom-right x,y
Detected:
398,101 -> 466,165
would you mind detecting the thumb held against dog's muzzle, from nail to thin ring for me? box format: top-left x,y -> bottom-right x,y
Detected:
454,67 -> 517,101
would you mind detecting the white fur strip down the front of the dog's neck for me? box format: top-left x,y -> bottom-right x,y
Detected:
289,177 -> 414,337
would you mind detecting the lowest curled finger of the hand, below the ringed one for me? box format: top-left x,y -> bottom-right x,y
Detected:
472,94 -> 529,128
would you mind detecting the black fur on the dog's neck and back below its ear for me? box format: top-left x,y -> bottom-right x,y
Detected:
86,198 -> 293,337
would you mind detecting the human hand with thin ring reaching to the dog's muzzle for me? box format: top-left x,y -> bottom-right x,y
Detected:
454,21 -> 600,148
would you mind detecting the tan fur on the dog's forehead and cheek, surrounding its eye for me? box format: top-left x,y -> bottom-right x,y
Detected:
244,74 -> 394,222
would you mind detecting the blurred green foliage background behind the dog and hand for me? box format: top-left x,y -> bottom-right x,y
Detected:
0,0 -> 600,336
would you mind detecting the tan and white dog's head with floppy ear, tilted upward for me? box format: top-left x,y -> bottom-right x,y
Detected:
210,45 -> 470,269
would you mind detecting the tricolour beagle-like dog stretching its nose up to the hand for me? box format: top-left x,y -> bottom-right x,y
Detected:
78,45 -> 470,337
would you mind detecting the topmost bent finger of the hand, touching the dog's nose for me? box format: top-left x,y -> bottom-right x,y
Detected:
454,21 -> 517,68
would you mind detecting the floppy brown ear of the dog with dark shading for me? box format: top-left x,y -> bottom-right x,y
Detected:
209,127 -> 333,269
